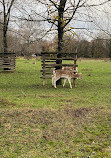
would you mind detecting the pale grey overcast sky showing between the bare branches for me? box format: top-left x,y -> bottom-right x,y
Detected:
0,0 -> 111,39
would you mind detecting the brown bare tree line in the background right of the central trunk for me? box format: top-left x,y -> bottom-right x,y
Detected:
60,37 -> 111,58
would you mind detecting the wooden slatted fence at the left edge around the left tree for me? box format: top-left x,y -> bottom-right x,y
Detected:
0,52 -> 16,71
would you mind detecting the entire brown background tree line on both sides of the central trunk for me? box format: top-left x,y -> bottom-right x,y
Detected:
0,19 -> 111,58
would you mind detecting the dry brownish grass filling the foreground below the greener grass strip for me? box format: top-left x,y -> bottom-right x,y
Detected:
0,106 -> 111,158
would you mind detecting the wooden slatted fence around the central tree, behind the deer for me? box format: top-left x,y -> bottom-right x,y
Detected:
41,52 -> 78,87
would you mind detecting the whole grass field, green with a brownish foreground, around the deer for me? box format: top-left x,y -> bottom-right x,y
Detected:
0,58 -> 111,158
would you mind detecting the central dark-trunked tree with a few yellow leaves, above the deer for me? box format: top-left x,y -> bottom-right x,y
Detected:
30,0 -> 110,83
